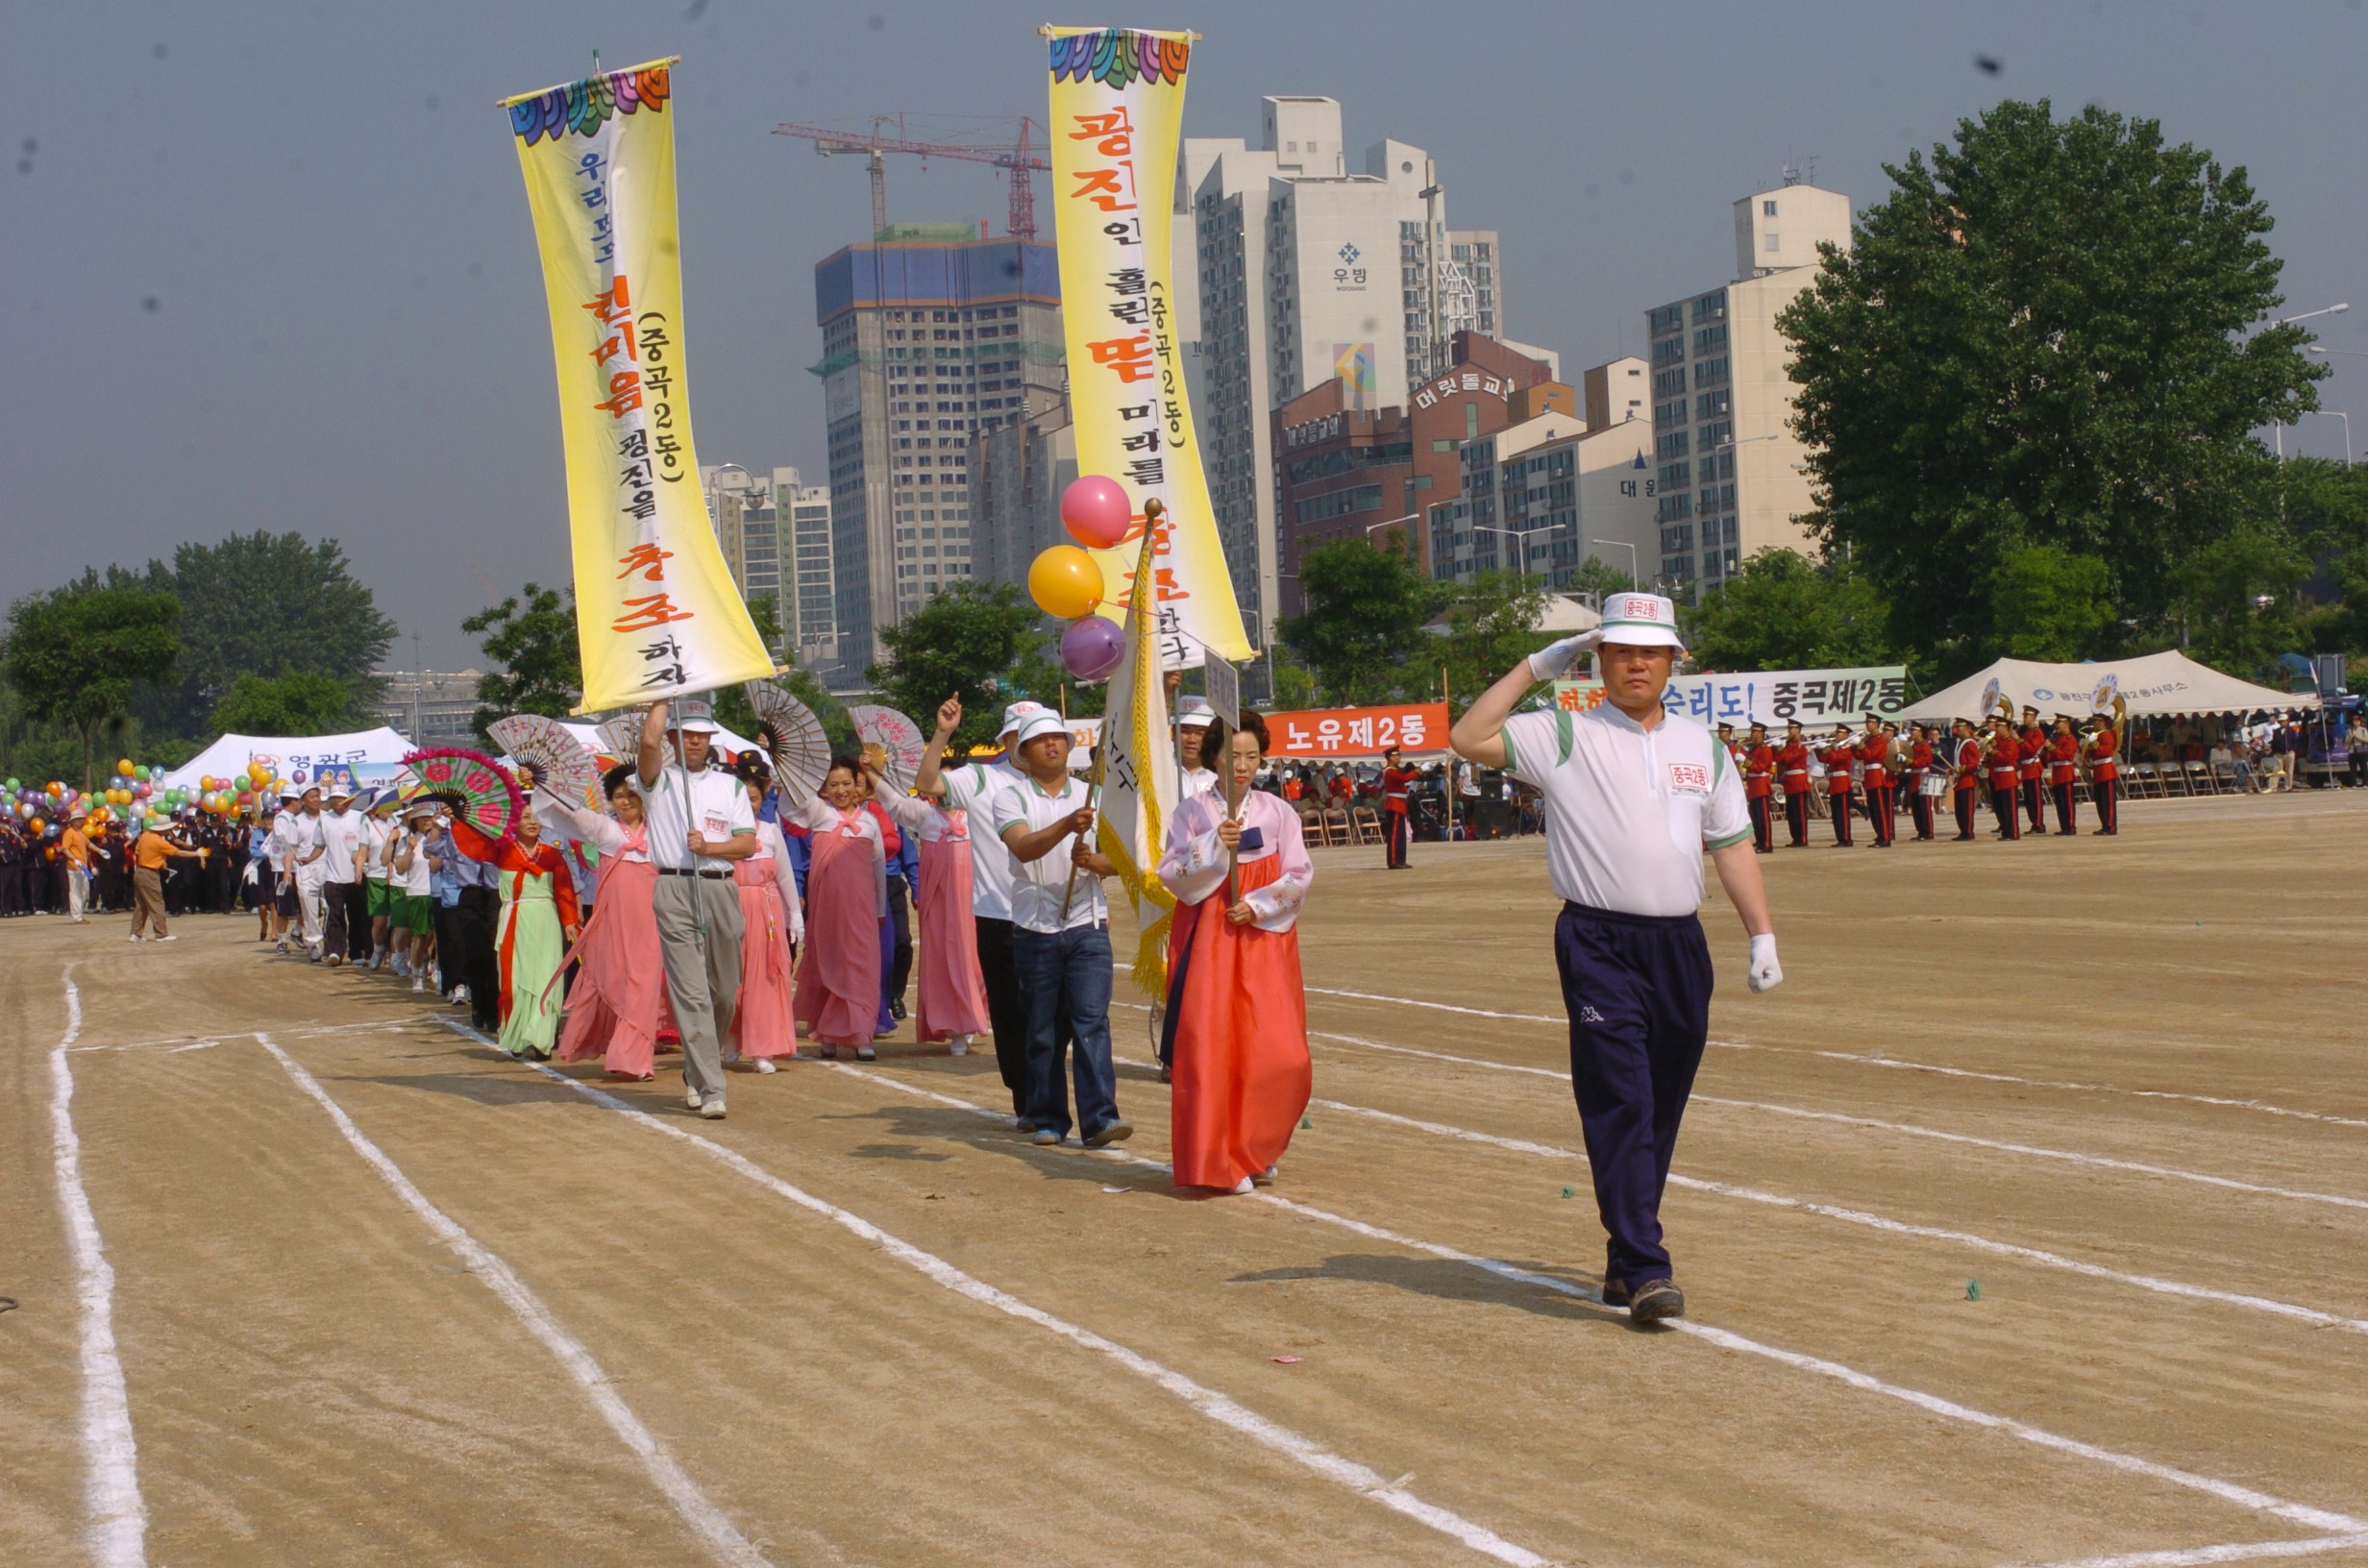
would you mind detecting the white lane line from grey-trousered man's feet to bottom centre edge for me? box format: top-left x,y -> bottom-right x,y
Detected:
438,1018 -> 1553,1568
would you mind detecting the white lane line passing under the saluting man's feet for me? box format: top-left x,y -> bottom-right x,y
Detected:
824,1064 -> 2368,1532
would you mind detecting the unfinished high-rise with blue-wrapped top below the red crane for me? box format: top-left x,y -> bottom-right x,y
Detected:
812,225 -> 1066,677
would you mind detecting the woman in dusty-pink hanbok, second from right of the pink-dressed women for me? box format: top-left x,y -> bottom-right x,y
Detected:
779,758 -> 888,1061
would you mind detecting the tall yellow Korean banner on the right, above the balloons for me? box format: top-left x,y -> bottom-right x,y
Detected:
1045,29 -> 1250,671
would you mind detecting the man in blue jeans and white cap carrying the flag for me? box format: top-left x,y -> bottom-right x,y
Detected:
987,713 -> 1134,1149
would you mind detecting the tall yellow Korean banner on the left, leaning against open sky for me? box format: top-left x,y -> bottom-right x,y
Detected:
505,60 -> 772,711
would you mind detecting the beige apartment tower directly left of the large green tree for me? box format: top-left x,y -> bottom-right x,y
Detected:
1645,184 -> 1849,597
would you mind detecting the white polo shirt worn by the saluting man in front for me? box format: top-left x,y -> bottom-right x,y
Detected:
1504,703 -> 1752,915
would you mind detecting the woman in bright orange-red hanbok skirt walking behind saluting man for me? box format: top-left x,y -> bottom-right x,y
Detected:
1160,713 -> 1317,1193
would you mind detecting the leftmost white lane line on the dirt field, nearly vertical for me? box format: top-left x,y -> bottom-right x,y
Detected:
50,964 -> 147,1568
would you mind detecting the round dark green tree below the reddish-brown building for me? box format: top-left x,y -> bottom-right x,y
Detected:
1276,540 -> 1451,703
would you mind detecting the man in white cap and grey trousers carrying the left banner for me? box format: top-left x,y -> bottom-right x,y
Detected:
632,697 -> 755,1120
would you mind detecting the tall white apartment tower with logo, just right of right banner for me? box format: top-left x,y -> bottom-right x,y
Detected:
1177,97 -> 1504,645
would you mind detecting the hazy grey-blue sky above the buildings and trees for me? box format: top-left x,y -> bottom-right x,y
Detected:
0,0 -> 2368,668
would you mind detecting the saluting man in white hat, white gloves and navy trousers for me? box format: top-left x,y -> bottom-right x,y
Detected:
1449,592 -> 1783,1324
